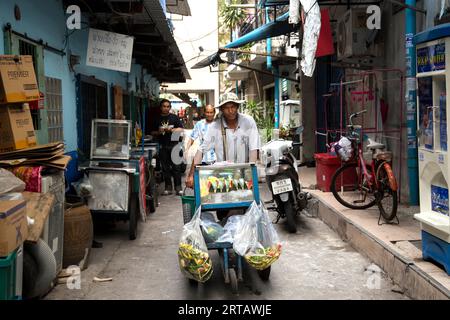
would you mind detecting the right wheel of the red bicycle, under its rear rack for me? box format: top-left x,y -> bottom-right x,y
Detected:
377,163 -> 398,221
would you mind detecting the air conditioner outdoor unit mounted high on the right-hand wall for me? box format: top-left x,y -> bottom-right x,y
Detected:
337,9 -> 377,61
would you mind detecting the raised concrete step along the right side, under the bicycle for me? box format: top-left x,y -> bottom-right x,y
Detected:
311,190 -> 450,300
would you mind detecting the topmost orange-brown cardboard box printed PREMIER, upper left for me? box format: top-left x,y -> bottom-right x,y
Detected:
0,55 -> 39,104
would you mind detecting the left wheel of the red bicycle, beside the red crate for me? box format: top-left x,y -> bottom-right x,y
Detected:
330,163 -> 377,210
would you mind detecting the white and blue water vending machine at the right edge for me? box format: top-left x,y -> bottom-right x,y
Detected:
414,24 -> 450,275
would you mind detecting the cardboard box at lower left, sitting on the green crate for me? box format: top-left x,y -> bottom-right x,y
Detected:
0,200 -> 28,257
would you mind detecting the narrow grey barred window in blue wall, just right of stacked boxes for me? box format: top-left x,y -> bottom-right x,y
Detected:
45,77 -> 64,143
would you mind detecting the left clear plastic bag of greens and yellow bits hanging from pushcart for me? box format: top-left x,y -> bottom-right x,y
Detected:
178,206 -> 213,282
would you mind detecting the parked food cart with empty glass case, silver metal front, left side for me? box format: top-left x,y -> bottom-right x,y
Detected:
80,119 -> 140,240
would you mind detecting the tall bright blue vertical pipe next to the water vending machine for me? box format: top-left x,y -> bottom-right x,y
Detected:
405,0 -> 419,205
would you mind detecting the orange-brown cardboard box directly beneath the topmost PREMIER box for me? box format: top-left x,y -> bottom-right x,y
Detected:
0,103 -> 36,153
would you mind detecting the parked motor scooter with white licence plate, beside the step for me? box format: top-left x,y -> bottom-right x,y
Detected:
261,127 -> 311,233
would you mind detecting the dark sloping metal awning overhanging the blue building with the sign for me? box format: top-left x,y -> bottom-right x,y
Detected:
63,0 -> 190,83
